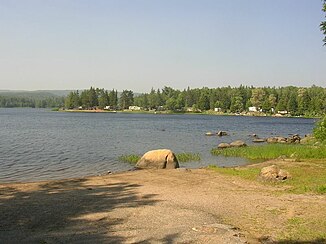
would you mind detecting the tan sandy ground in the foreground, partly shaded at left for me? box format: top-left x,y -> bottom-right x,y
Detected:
0,169 -> 326,243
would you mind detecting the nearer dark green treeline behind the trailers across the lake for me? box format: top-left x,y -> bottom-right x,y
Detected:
65,85 -> 326,116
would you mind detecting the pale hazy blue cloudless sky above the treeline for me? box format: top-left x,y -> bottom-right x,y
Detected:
0,0 -> 326,92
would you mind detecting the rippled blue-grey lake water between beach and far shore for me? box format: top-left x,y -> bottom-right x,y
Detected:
0,108 -> 315,182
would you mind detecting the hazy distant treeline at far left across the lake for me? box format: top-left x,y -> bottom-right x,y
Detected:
0,94 -> 65,108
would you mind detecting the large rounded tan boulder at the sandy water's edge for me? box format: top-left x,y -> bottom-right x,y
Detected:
136,149 -> 179,169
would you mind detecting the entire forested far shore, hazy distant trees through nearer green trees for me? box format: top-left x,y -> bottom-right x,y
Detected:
0,85 -> 326,117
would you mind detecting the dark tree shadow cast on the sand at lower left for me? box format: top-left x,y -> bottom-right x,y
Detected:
0,179 -> 175,243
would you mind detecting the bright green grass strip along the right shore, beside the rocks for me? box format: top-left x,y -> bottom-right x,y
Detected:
211,144 -> 326,160
